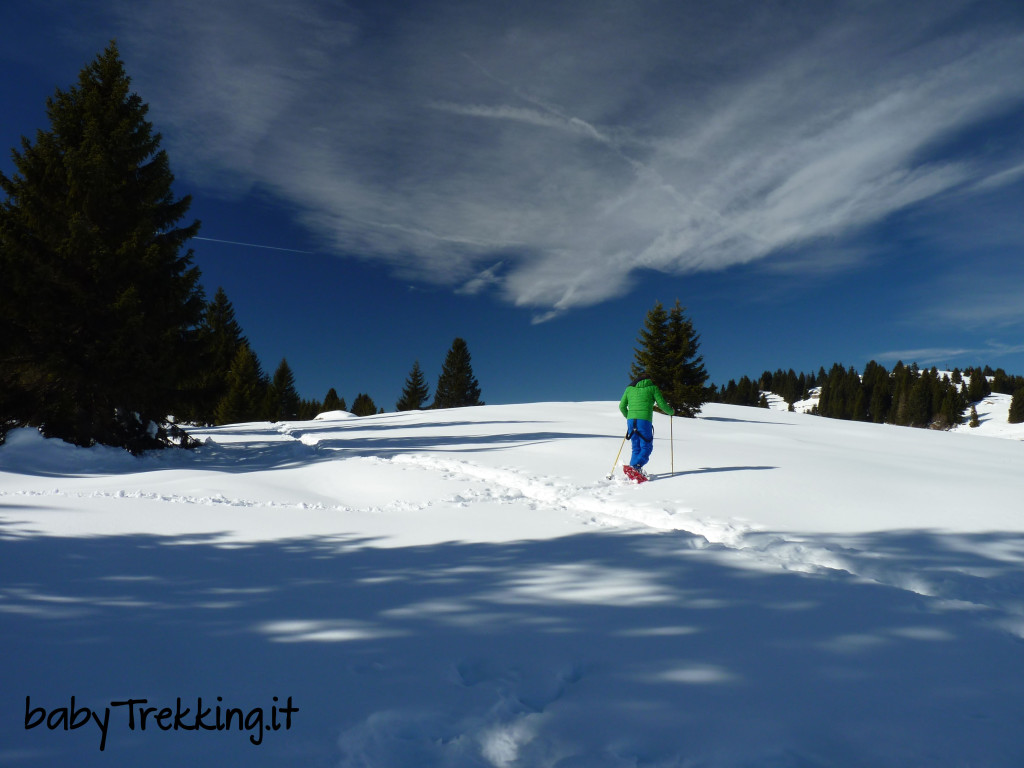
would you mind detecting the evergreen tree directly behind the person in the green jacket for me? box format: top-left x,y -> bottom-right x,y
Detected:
630,300 -> 708,418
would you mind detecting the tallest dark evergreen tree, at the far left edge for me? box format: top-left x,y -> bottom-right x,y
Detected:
0,43 -> 204,453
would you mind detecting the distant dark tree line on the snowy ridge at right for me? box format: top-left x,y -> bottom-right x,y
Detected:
712,360 -> 1024,429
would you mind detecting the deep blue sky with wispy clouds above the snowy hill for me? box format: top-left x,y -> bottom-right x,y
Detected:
0,0 -> 1024,410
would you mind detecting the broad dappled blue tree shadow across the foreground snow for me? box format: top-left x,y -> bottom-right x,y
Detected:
0,531 -> 1024,768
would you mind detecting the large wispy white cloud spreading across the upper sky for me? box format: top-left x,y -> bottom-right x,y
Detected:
105,0 -> 1024,318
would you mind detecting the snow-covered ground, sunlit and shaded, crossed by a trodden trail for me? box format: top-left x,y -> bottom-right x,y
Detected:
0,405 -> 1024,768
